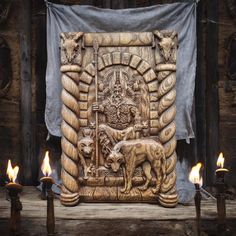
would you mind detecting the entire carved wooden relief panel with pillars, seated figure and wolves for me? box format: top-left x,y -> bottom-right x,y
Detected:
61,31 -> 178,207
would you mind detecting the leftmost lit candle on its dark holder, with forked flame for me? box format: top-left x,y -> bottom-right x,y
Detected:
6,160 -> 23,235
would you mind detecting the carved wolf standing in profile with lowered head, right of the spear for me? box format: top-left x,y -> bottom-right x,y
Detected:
107,139 -> 166,194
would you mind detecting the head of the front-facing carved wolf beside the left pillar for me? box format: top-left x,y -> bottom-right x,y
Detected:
77,128 -> 94,158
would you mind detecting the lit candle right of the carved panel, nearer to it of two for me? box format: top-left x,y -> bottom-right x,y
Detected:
189,163 -> 203,236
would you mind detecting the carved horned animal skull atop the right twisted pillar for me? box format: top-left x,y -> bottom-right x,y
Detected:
154,31 -> 177,62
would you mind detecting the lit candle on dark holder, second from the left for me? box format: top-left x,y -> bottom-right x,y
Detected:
40,151 -> 55,235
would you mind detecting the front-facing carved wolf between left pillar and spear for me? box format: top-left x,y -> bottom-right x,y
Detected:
77,128 -> 94,179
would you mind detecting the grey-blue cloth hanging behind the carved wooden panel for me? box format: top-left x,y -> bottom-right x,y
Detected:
45,2 -> 196,139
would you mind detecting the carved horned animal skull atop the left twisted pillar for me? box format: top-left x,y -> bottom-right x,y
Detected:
61,32 -> 83,63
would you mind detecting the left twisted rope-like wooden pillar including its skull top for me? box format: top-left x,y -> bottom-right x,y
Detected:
61,32 -> 83,206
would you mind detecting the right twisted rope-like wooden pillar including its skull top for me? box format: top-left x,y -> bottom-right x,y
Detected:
154,31 -> 178,207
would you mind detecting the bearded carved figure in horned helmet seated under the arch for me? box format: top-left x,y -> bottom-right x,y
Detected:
92,71 -> 142,156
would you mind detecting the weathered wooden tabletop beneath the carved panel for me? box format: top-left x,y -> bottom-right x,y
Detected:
0,187 -> 236,220
